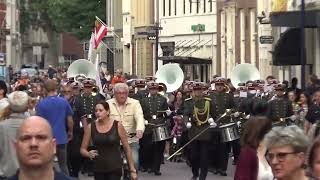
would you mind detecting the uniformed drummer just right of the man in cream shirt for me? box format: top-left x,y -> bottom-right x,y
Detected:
141,82 -> 168,176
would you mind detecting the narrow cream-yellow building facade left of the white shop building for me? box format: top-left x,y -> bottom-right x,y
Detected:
122,0 -> 154,77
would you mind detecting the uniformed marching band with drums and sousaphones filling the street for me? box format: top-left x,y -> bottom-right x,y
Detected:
5,59 -> 310,180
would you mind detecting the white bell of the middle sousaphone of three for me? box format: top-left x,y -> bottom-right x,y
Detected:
155,64 -> 184,92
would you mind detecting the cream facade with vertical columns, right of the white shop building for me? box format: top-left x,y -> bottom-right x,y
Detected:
217,0 -> 259,77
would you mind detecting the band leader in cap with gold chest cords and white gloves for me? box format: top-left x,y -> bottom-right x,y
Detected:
183,83 -> 216,180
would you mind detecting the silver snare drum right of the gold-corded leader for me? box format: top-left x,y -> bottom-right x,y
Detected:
219,123 -> 240,142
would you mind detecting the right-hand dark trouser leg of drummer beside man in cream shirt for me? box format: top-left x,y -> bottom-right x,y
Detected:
152,141 -> 166,171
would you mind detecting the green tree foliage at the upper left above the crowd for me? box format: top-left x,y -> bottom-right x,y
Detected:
20,0 -> 106,40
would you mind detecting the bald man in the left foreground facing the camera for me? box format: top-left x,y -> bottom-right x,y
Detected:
9,116 -> 71,180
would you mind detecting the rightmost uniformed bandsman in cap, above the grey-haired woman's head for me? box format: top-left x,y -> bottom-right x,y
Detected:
267,84 -> 296,125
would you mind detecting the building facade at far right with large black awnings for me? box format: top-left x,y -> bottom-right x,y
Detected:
257,0 -> 320,85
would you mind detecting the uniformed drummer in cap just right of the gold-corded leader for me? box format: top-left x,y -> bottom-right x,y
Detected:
210,78 -> 235,176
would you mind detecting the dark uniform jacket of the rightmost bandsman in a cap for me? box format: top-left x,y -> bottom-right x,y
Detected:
267,96 -> 293,122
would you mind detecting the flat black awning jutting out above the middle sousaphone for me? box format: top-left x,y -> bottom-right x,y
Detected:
159,56 -> 212,64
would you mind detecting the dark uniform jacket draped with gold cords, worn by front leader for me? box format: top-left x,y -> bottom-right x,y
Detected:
183,97 -> 216,141
